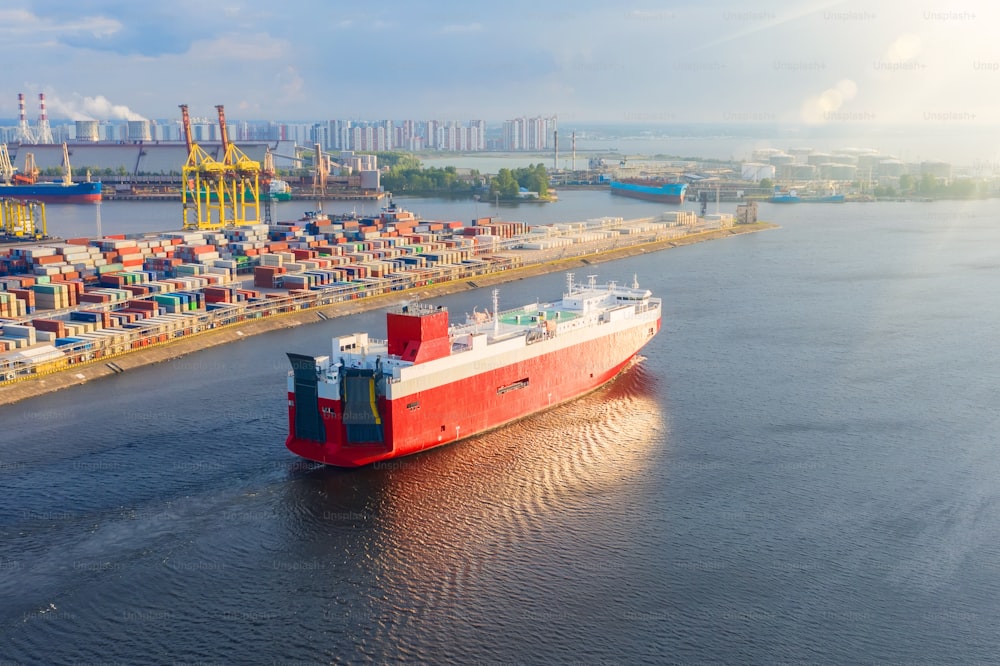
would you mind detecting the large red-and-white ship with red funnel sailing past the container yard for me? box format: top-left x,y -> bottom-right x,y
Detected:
286,275 -> 661,467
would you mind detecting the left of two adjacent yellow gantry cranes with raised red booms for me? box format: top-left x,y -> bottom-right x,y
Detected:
180,104 -> 226,230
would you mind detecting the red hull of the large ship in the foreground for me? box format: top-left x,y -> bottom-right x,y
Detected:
286,315 -> 660,467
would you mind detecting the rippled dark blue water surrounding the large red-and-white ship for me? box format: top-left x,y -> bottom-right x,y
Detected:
0,193 -> 1000,664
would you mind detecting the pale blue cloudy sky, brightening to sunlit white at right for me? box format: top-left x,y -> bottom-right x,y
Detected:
0,0 -> 1000,128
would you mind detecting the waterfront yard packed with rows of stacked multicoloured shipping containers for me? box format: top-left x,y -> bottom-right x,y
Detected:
0,207 -> 760,386
